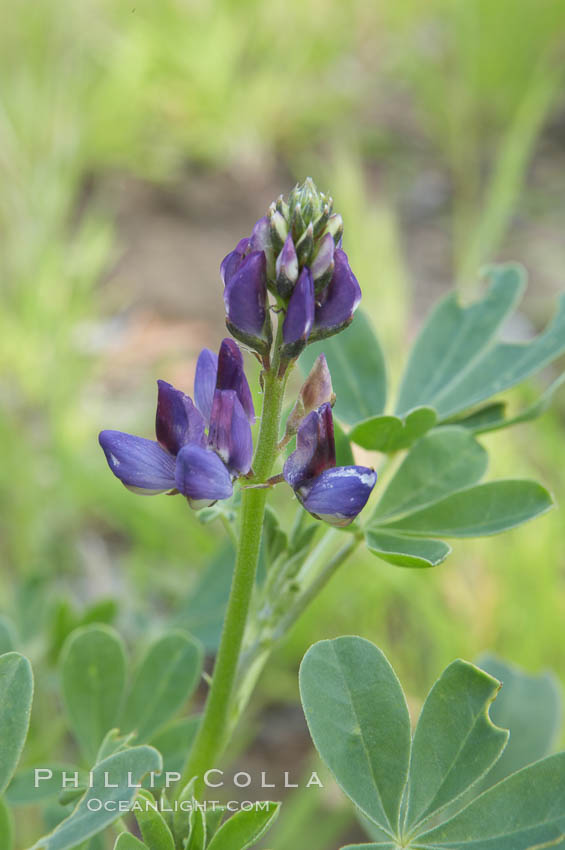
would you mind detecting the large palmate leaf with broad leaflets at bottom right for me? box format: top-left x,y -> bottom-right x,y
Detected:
300,637 -> 565,850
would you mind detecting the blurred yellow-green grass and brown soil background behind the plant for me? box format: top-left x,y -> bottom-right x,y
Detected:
0,0 -> 565,850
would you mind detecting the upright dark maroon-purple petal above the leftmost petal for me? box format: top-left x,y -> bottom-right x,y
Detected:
155,381 -> 205,455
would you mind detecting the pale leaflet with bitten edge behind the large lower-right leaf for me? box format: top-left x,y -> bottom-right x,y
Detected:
477,655 -> 562,790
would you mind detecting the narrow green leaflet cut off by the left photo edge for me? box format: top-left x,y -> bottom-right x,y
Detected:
0,652 -> 33,795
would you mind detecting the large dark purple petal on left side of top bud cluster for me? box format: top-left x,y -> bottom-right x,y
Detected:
224,251 -> 267,340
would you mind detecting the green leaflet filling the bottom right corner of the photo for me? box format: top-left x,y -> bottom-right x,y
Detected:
417,753 -> 565,850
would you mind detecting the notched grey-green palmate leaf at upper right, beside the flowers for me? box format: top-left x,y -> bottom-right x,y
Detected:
396,265 -> 565,427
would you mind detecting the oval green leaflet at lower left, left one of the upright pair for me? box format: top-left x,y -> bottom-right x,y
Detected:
61,626 -> 126,763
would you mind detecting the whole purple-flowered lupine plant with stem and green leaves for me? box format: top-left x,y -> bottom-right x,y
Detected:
0,179 -> 565,850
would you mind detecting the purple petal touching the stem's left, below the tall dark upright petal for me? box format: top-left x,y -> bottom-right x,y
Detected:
208,390 -> 253,475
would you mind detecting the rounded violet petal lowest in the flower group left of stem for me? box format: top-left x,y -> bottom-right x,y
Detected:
176,445 -> 233,509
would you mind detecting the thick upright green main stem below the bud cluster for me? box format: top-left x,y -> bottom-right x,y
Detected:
179,363 -> 286,797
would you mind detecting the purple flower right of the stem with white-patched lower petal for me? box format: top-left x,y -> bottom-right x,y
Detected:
283,403 -> 377,527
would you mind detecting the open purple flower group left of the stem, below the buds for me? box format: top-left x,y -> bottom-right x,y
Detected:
99,339 -> 255,509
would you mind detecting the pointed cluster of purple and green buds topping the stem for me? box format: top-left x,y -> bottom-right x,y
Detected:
221,178 -> 361,365
